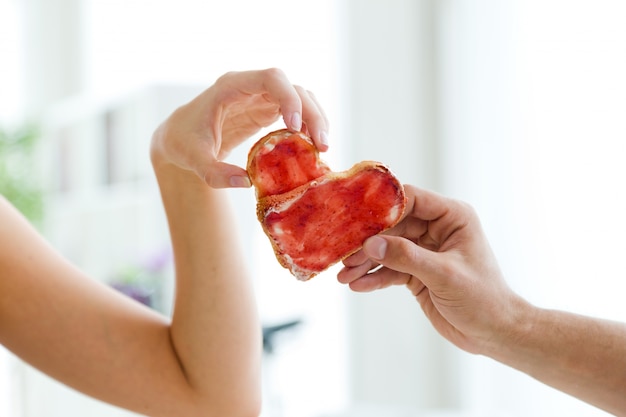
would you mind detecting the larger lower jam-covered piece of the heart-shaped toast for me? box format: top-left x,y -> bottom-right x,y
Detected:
265,167 -> 404,279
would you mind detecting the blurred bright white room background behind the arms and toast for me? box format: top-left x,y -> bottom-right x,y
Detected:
0,0 -> 626,417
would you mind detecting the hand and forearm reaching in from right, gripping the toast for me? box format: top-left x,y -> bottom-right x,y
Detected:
338,185 -> 626,415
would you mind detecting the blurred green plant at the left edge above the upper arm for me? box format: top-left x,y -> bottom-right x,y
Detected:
0,125 -> 44,224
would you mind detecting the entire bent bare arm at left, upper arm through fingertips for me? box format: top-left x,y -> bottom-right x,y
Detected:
0,69 -> 328,417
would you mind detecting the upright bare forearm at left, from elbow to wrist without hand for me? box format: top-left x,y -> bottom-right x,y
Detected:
153,157 -> 261,416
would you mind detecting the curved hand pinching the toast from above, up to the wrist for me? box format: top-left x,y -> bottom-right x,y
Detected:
151,68 -> 328,188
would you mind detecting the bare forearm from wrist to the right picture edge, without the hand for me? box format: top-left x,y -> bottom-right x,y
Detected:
486,304 -> 626,415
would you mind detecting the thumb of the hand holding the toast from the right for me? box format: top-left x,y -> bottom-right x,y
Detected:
363,235 -> 449,288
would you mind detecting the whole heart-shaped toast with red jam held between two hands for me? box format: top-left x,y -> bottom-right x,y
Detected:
247,130 -> 406,281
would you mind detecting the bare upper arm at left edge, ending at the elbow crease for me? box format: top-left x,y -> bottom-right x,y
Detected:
0,199 -> 194,416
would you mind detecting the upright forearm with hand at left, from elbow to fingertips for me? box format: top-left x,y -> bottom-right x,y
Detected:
141,68 -> 328,416
